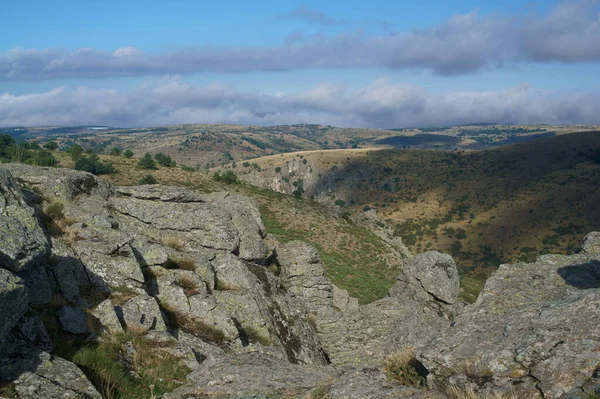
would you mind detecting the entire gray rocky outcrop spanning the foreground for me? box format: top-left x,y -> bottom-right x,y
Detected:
0,164 -> 600,399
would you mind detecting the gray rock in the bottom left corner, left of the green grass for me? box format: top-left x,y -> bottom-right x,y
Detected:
14,353 -> 102,399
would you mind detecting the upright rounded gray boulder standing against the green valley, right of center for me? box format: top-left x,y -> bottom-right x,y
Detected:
404,251 -> 460,304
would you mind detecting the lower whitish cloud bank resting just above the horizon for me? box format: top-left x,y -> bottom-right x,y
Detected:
0,76 -> 600,128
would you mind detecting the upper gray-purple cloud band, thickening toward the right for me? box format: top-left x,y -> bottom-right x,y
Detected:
0,0 -> 600,80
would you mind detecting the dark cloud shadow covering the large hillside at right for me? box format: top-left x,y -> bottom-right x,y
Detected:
307,132 -> 600,270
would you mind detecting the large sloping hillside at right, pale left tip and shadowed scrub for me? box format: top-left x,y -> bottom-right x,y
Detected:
225,132 -> 600,300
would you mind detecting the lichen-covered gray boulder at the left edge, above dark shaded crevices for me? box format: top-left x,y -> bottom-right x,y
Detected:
0,166 -> 49,273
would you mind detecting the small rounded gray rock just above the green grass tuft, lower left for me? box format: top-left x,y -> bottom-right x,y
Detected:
122,294 -> 167,334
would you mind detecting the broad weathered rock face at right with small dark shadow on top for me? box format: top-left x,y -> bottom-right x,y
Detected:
418,252 -> 600,398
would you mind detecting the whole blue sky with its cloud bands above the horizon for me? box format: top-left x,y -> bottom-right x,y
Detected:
0,0 -> 600,128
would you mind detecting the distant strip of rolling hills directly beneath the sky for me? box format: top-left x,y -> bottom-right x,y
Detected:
18,124 -> 599,168
